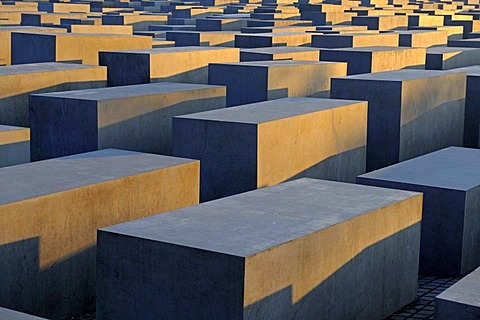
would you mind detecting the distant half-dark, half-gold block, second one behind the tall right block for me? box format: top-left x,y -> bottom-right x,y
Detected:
312,33 -> 399,48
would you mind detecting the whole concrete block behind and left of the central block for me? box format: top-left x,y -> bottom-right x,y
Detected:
30,82 -> 226,161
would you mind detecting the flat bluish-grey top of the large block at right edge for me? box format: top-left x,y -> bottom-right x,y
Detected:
360,147 -> 480,191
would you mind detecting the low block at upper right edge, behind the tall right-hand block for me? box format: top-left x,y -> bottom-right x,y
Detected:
425,47 -> 480,70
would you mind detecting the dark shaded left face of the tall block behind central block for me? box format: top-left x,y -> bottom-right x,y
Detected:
330,78 -> 402,171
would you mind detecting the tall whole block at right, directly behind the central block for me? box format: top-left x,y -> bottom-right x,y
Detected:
331,70 -> 466,171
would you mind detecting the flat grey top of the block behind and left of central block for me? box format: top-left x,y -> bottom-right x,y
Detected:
32,82 -> 220,101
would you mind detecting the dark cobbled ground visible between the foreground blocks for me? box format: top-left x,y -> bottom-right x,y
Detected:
68,277 -> 460,320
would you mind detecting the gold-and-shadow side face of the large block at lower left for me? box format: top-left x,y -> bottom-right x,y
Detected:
0,156 -> 199,319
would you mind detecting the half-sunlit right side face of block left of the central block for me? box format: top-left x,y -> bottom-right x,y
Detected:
98,87 -> 226,155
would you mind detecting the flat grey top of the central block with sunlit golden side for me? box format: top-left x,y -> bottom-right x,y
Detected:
175,98 -> 362,124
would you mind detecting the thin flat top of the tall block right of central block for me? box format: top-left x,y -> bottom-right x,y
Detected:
336,70 -> 462,81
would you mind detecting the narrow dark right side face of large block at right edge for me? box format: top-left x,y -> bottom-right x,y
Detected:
461,187 -> 480,274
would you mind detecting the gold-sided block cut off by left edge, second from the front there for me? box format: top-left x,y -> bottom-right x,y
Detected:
0,63 -> 107,127
